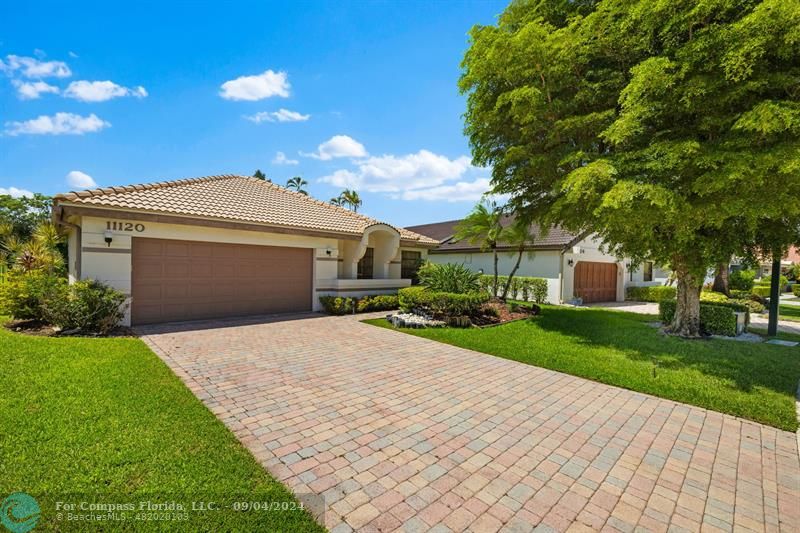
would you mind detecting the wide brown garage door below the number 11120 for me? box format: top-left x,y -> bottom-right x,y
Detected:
131,237 -> 313,324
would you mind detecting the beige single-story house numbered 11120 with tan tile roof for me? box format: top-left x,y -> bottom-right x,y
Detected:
53,175 -> 438,325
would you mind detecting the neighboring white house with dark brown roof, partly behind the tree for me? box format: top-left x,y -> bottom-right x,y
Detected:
406,217 -> 668,303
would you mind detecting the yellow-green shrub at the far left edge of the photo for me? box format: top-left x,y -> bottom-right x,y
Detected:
0,270 -> 67,322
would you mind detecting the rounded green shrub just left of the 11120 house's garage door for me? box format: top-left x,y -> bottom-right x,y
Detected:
42,280 -> 125,334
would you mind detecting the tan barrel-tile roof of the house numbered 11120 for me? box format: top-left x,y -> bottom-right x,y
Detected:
55,175 -> 436,245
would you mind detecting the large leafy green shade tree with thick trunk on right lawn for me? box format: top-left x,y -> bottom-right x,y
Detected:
460,0 -> 800,336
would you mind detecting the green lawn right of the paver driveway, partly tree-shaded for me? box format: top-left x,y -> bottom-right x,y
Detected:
367,306 -> 800,431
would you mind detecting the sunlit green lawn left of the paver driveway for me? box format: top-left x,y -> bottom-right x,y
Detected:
0,320 -> 324,532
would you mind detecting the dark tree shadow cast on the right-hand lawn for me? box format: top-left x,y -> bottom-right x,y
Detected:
535,309 -> 800,394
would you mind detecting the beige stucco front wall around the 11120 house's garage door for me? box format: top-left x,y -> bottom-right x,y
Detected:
68,215 -> 426,325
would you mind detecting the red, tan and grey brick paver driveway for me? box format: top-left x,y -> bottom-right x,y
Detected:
141,316 -> 800,532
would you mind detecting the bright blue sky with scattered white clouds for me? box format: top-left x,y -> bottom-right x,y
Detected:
0,1 -> 505,225
